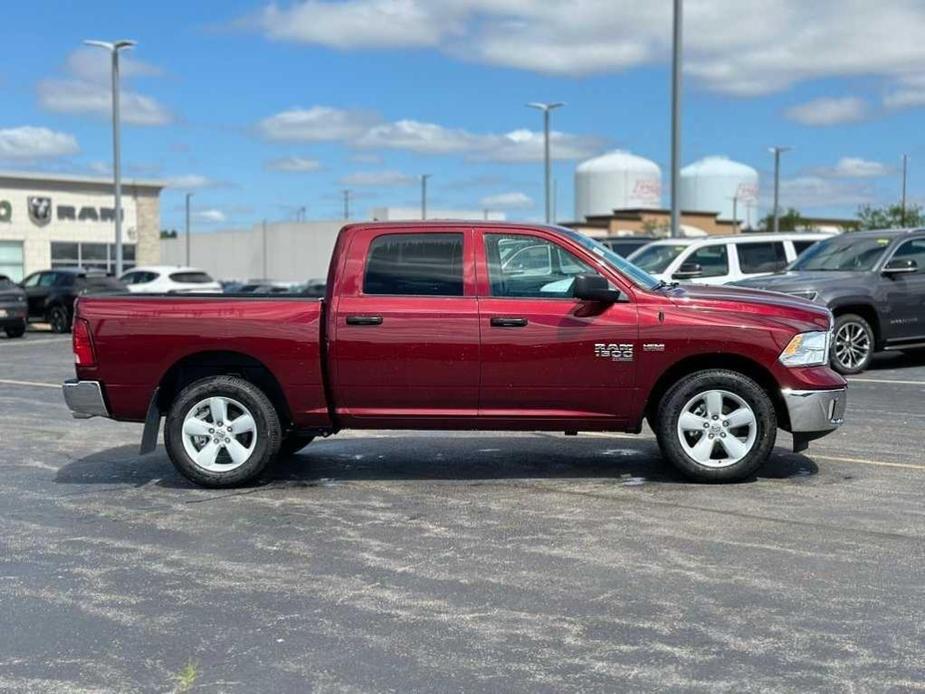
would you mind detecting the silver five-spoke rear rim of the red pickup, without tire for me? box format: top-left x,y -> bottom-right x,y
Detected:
183,396 -> 257,472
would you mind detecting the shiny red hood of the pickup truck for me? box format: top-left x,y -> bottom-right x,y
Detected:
671,284 -> 831,332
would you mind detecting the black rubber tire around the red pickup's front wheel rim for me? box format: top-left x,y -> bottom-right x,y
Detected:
654,369 -> 777,482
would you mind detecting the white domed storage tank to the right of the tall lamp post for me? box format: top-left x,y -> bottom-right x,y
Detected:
680,157 -> 758,224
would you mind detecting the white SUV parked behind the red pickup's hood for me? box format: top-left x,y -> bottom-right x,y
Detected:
627,231 -> 832,284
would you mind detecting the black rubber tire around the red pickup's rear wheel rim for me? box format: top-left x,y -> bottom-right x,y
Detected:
164,376 -> 282,488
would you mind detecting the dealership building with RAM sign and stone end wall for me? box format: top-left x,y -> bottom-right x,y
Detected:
0,171 -> 164,281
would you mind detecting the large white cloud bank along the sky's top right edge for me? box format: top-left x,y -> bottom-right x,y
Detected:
250,0 -> 925,96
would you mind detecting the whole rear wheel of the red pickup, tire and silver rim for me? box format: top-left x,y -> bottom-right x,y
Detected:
164,376 -> 281,487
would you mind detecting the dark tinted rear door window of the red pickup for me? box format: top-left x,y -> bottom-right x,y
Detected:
363,232 -> 463,296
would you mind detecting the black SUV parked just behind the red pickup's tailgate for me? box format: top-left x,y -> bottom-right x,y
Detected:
21,268 -> 128,333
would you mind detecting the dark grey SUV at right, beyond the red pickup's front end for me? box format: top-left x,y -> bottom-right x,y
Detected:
732,229 -> 925,374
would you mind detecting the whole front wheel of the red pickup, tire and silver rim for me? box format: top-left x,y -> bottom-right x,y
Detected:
655,369 -> 777,482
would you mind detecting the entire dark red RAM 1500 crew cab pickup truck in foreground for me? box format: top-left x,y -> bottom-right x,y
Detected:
64,221 -> 846,487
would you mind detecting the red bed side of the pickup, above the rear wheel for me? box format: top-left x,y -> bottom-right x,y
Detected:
75,294 -> 330,428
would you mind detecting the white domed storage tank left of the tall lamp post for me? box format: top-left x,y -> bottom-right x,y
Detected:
575,149 -> 662,220
